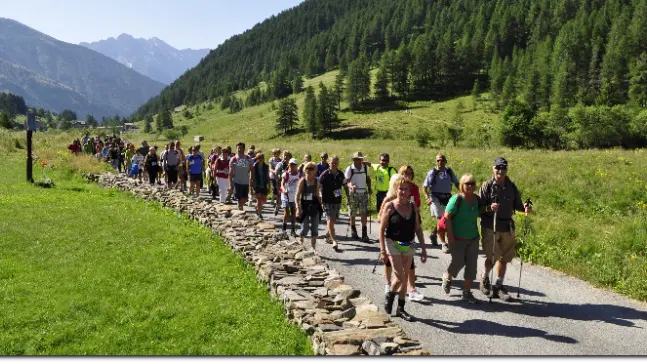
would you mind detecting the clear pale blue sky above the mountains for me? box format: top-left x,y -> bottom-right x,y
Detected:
0,0 -> 303,49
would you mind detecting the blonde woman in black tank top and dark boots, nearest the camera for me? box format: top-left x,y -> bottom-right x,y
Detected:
379,175 -> 427,321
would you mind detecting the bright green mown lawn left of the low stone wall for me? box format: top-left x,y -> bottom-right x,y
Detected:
0,155 -> 311,355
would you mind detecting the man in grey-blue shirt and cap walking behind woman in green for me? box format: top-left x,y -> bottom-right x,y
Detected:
423,153 -> 460,253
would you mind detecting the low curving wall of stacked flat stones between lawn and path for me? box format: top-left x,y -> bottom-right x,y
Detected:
86,173 -> 429,355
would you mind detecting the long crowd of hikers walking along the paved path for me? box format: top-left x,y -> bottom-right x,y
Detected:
68,138 -> 532,320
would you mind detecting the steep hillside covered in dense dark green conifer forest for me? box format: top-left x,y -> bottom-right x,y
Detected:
136,0 -> 647,147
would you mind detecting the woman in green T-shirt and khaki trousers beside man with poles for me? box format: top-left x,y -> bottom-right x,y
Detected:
438,174 -> 480,303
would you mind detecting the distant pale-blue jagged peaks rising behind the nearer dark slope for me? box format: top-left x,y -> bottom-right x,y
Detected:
79,34 -> 210,85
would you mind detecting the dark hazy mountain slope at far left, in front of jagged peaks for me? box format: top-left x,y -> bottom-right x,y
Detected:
0,18 -> 164,119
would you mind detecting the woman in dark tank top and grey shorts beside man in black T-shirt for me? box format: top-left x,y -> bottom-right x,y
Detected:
296,162 -> 323,254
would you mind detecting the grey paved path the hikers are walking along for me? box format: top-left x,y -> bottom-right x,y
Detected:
185,186 -> 647,355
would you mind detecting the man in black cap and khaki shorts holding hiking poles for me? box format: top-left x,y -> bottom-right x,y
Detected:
478,157 -> 532,301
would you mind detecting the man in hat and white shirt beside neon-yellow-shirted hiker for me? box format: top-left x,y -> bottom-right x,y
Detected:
344,152 -> 371,243
